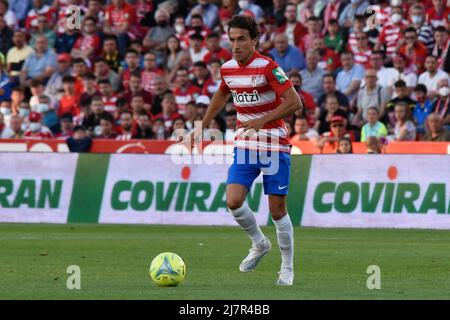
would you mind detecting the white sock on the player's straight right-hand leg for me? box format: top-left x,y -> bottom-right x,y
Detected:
272,214 -> 294,270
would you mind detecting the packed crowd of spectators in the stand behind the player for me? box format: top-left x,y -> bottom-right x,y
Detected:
0,0 -> 450,153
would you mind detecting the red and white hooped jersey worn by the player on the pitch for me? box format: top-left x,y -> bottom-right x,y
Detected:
220,51 -> 292,153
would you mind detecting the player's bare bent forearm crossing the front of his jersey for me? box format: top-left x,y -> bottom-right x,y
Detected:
238,87 -> 303,130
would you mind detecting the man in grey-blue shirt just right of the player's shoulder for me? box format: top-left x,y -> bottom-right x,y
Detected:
300,50 -> 325,100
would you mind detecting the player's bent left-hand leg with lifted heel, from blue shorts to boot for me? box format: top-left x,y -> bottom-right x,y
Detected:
227,149 -> 271,272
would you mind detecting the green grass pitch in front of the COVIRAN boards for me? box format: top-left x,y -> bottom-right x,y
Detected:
0,224 -> 450,299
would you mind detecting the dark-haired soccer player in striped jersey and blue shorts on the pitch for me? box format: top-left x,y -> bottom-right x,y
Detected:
191,16 -> 303,285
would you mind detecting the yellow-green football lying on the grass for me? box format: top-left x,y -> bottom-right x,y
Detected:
149,252 -> 186,287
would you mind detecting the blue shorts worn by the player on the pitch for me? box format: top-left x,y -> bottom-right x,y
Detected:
227,148 -> 291,195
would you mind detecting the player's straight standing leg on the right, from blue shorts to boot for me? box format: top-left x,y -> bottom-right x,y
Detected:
263,153 -> 294,285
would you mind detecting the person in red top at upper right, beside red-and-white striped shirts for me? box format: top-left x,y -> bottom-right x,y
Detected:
399,27 -> 428,73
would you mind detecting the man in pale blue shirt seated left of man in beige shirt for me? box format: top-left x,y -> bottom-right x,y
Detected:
336,52 -> 365,102
